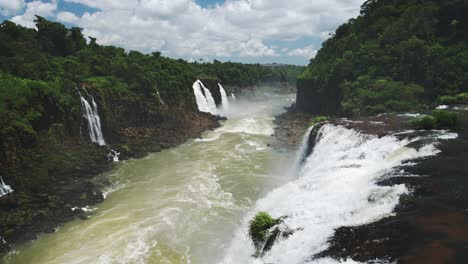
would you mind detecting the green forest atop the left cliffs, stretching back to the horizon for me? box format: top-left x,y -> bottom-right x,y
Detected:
0,16 -> 303,143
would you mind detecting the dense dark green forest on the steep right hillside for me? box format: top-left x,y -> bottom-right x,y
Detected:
299,0 -> 468,116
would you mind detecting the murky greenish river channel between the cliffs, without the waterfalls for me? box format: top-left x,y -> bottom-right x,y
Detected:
4,94 -> 295,264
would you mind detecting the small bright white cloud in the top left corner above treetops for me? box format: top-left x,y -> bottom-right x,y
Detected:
10,0 -> 57,28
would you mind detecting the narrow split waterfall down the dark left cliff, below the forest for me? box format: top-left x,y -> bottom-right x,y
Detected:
80,93 -> 106,146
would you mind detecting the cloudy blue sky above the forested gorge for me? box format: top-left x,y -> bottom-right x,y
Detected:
0,0 -> 364,65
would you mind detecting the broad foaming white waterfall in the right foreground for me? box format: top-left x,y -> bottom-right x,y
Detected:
221,124 -> 448,264
